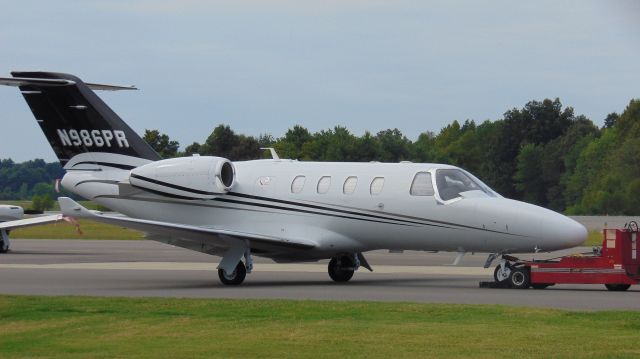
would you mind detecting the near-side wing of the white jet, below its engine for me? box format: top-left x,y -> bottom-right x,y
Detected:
58,197 -> 316,254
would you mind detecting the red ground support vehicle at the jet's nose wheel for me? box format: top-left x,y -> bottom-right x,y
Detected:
494,222 -> 640,291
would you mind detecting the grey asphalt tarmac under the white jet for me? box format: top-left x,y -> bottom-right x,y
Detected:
0,239 -> 640,310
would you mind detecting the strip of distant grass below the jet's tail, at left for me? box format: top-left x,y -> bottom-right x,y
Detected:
11,219 -> 144,239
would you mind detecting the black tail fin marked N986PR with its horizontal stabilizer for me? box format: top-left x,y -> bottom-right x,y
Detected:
0,72 -> 161,168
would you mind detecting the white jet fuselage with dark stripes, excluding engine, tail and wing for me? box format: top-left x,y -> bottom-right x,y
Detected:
62,160 -> 586,260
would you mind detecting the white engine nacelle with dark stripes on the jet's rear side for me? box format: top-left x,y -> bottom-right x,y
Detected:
129,156 -> 236,199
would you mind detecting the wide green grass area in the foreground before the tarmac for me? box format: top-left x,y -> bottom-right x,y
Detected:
0,296 -> 640,358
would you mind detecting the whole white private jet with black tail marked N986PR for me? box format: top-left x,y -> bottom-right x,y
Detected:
0,72 -> 587,284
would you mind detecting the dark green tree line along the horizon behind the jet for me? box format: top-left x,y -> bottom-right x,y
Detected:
0,99 -> 640,215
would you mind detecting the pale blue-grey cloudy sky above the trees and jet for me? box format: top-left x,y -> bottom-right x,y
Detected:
0,0 -> 640,162
